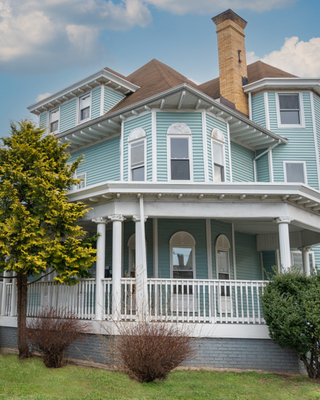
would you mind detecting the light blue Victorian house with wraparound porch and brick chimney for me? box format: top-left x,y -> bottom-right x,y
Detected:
0,10 -> 320,372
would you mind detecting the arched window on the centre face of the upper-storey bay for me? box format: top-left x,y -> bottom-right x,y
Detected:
167,122 -> 192,181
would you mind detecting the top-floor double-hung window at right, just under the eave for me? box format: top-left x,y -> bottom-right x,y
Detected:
278,93 -> 302,126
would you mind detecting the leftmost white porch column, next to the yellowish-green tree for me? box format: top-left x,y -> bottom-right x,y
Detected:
92,218 -> 108,321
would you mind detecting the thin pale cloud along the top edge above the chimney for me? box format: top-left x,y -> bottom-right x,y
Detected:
145,0 -> 297,15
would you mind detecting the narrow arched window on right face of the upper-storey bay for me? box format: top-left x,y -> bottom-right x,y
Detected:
211,128 -> 225,182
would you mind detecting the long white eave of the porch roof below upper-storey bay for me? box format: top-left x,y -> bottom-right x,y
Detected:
68,182 -> 320,215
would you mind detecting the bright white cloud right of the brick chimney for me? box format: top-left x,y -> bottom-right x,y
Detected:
247,36 -> 320,78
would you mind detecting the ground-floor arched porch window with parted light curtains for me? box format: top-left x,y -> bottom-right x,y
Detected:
170,231 -> 196,279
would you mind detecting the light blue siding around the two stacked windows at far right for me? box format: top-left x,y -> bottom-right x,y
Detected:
268,92 -> 319,189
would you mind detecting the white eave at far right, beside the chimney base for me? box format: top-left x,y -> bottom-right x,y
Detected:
243,78 -> 320,96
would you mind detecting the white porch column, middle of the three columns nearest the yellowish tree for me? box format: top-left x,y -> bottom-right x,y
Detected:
108,214 -> 125,321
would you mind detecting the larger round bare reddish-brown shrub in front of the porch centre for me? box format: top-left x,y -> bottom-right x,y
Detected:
113,322 -> 194,382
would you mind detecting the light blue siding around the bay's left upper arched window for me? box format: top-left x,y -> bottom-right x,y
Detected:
123,113 -> 152,181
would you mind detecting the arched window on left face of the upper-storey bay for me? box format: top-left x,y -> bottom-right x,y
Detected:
128,128 -> 147,181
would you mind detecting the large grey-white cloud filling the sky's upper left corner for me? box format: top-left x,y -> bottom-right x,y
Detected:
0,0 -> 152,72
